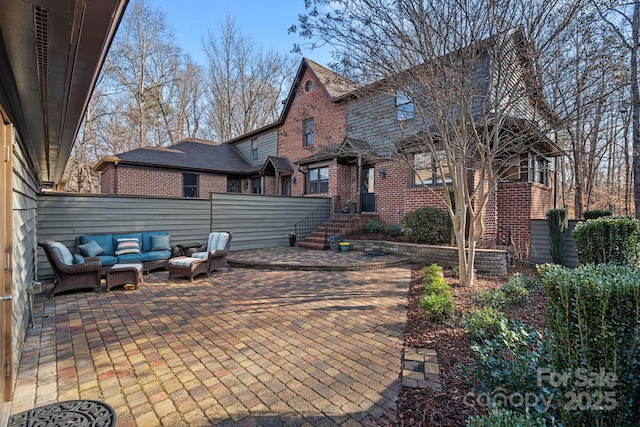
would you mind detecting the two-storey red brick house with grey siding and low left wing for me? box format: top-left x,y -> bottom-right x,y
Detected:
96,34 -> 561,257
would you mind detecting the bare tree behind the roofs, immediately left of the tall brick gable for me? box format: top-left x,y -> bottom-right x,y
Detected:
203,15 -> 295,141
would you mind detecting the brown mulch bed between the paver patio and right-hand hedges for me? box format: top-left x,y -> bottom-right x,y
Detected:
350,234 -> 546,427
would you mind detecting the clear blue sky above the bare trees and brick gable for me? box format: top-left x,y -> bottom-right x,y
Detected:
147,0 -> 331,66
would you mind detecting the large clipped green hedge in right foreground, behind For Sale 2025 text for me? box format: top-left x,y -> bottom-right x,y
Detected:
539,264 -> 640,427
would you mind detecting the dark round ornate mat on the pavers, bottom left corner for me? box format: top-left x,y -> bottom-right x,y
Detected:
9,400 -> 116,427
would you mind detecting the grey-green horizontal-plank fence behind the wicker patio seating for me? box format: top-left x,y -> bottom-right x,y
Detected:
36,193 -> 327,279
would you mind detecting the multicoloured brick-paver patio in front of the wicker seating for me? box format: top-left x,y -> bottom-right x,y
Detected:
12,248 -> 410,427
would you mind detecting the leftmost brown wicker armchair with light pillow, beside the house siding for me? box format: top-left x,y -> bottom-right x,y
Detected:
38,240 -> 102,296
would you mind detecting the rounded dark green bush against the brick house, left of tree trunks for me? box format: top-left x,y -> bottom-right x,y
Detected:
403,207 -> 453,245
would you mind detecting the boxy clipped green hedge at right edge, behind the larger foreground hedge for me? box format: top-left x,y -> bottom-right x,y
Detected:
573,217 -> 640,267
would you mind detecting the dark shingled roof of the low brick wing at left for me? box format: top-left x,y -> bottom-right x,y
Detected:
95,139 -> 259,173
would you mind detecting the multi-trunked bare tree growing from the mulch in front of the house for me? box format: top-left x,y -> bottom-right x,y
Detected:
292,0 -> 581,285
